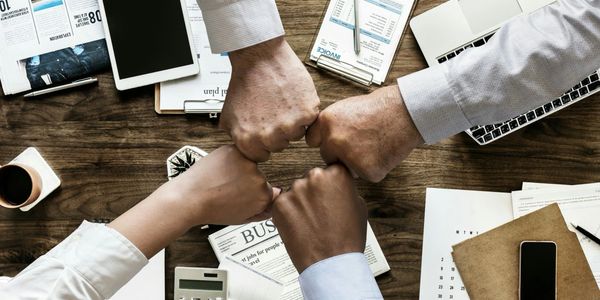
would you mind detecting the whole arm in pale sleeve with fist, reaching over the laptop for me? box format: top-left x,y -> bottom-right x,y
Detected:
306,0 -> 600,181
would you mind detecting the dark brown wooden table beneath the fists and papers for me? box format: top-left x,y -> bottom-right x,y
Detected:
0,0 -> 600,299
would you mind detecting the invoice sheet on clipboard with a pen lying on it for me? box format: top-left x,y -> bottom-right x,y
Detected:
306,0 -> 415,86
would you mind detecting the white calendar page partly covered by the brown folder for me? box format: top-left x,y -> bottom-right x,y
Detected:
419,188 -> 513,299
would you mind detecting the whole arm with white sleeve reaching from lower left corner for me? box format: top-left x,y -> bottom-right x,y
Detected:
0,146 -> 280,300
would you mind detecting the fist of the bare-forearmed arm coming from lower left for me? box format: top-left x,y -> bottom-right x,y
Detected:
161,146 -> 279,225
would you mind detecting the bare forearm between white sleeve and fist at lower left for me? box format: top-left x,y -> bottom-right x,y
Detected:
108,185 -> 198,258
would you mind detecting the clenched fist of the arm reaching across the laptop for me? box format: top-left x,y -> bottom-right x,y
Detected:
306,86 -> 423,182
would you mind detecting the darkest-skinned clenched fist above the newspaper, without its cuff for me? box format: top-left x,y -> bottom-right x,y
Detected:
272,165 -> 367,273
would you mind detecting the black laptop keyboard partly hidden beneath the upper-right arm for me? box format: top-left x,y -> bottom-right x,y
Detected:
438,33 -> 600,145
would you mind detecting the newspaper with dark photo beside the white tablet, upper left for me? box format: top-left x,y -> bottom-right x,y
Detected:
0,0 -> 110,94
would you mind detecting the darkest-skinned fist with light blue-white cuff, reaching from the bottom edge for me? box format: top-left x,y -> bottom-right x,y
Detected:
272,165 -> 383,300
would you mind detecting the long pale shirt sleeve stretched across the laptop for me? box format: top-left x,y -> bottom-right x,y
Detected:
398,0 -> 600,144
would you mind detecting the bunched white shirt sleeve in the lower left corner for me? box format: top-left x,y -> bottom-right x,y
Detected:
0,222 -> 148,300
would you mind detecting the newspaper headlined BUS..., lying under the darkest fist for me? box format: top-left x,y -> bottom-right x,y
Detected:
208,220 -> 390,300
